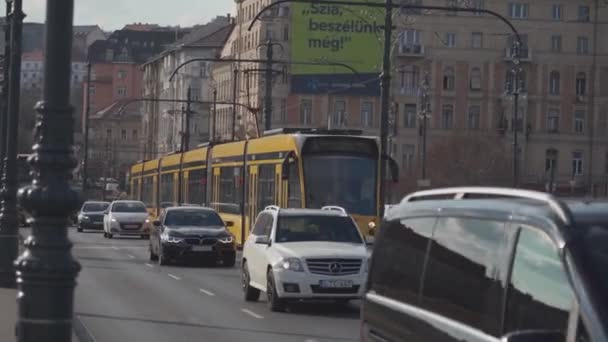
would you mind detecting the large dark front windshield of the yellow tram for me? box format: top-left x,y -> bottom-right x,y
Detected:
304,155 -> 378,215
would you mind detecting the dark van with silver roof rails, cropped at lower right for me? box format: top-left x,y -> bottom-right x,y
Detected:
360,187 -> 608,342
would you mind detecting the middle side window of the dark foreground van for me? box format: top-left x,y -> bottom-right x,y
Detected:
422,218 -> 508,336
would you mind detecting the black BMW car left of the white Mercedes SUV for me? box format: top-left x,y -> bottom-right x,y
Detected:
149,206 -> 236,267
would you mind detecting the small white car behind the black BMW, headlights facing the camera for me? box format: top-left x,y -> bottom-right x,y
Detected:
103,201 -> 151,239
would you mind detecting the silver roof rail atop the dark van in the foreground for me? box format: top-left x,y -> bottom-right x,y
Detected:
401,187 -> 572,224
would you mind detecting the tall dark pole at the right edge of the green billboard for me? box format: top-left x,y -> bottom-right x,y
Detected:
379,0 -> 393,217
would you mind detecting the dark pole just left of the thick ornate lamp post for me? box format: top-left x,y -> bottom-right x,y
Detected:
0,0 -> 25,287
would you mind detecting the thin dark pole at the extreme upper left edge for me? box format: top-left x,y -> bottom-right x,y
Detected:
0,2 -> 13,177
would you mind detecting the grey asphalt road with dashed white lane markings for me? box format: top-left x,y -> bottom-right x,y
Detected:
70,229 -> 359,342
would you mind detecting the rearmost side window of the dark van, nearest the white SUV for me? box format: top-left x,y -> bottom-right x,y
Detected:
370,217 -> 436,303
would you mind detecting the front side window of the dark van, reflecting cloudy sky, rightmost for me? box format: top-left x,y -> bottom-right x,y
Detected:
506,227 -> 574,334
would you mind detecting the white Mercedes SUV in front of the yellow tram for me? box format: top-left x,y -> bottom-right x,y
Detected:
242,206 -> 369,311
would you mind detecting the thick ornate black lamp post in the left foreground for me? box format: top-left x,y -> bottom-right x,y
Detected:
16,0 -> 81,342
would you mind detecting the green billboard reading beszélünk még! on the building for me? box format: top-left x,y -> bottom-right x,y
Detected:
291,0 -> 384,75
